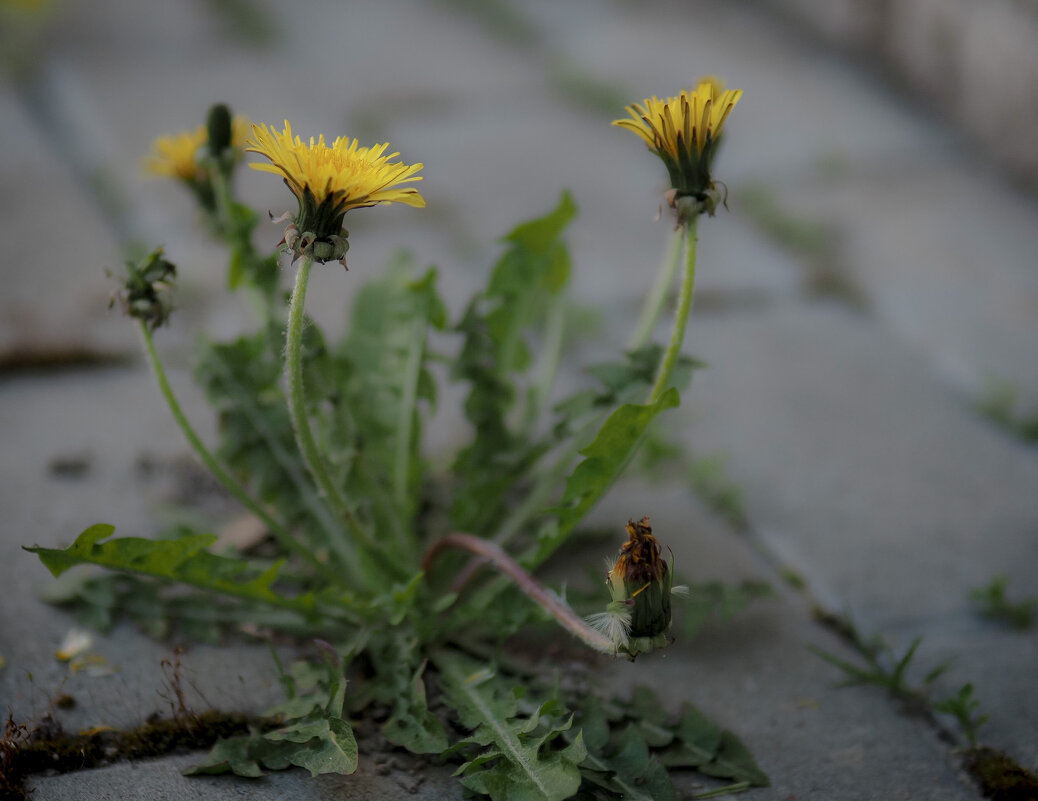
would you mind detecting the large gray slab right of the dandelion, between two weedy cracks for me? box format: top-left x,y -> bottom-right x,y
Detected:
682,307 -> 1038,759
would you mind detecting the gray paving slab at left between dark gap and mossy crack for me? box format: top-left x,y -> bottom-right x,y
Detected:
0,368 -> 281,731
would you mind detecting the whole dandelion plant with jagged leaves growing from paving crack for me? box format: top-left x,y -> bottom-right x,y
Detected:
20,87 -> 767,801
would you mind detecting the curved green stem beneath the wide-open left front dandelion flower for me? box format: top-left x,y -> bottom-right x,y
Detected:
284,255 -> 375,556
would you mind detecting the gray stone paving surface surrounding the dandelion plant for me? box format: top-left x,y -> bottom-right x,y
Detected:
0,0 -> 1038,800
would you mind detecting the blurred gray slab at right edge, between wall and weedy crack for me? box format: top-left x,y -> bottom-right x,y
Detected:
736,159 -> 1038,408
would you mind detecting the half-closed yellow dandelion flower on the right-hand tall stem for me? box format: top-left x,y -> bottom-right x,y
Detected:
612,77 -> 742,200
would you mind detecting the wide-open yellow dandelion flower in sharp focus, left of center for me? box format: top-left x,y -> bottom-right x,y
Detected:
245,120 -> 426,260
